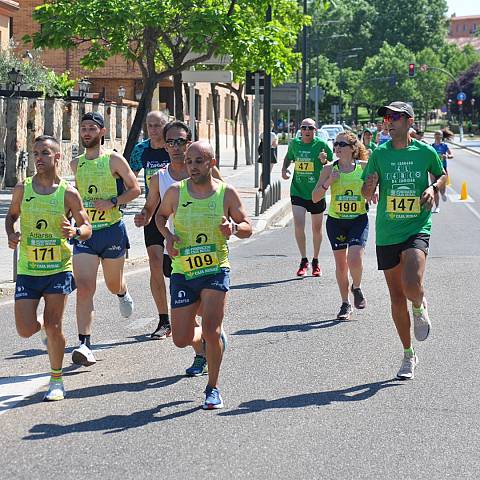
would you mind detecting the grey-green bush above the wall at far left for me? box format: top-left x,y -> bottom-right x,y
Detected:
0,45 -> 75,96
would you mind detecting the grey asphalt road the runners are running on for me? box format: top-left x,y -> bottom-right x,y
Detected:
0,144 -> 480,480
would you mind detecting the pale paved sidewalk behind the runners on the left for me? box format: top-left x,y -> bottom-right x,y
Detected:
0,145 -> 291,296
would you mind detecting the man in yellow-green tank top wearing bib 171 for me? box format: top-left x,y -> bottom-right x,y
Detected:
5,135 -> 92,401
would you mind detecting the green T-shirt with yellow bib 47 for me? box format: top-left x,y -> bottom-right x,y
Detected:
287,137 -> 333,200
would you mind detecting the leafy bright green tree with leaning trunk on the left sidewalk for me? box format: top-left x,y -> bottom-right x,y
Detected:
26,0 -> 304,157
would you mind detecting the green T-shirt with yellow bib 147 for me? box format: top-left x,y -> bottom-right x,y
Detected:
362,140 -> 443,245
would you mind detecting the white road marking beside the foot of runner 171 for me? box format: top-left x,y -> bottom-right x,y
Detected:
0,373 -> 50,415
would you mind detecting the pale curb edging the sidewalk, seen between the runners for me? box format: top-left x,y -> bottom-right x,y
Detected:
0,197 -> 291,298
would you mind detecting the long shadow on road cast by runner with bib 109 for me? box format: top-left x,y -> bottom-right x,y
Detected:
22,400 -> 201,440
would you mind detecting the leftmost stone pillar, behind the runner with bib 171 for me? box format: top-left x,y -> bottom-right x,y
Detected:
5,97 -> 28,187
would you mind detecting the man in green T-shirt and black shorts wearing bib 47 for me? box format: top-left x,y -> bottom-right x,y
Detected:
282,118 -> 333,277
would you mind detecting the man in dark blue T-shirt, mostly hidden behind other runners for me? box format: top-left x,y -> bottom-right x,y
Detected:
130,111 -> 171,339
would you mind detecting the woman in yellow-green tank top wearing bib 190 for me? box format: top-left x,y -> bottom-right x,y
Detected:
312,132 -> 368,320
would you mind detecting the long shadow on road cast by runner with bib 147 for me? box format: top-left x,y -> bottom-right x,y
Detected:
219,379 -> 402,417
